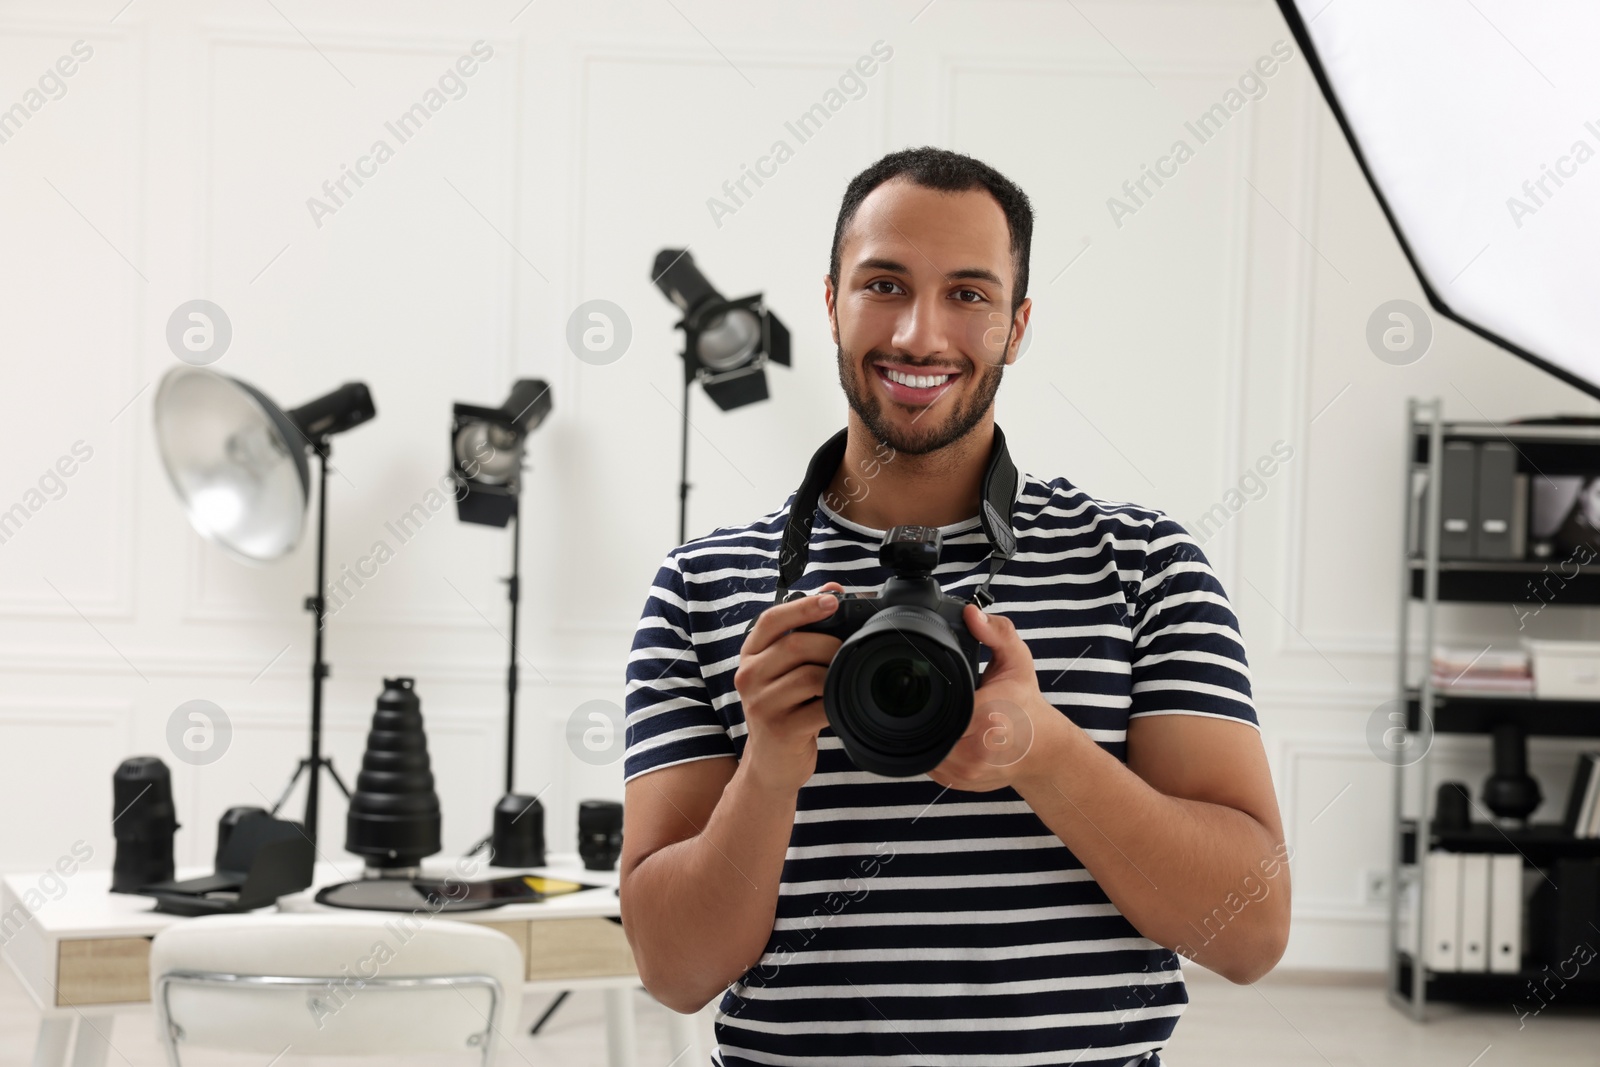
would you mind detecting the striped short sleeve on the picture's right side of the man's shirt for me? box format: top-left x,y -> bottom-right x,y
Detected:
1128,515 -> 1261,729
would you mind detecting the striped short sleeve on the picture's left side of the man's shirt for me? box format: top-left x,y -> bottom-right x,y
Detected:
622,555 -> 738,782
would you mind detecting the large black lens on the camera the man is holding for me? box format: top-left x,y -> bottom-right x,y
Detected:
822,605 -> 976,777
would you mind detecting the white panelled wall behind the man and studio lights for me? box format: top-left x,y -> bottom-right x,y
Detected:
0,0 -> 1595,968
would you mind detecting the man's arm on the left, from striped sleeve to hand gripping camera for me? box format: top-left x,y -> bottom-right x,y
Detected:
621,576 -> 840,1014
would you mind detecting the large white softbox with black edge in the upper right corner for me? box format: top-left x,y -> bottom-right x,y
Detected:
1278,0 -> 1600,397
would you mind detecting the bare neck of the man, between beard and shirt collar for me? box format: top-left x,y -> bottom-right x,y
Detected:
822,410 -> 994,530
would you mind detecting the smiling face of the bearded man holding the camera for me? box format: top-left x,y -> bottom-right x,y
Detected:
827,178 -> 1032,456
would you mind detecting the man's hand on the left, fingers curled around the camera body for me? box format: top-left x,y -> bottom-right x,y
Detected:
733,582 -> 845,792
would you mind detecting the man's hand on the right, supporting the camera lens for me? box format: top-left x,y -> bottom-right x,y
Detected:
928,605 -> 1072,793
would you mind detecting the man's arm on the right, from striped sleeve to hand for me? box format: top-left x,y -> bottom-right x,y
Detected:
933,520 -> 1290,984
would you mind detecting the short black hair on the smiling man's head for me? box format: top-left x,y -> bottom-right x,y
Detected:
827,146 -> 1034,314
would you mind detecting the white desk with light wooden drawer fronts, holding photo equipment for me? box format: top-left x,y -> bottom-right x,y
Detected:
0,854 -> 706,1067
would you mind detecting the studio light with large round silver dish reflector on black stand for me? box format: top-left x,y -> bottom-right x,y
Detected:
155,366 -> 376,843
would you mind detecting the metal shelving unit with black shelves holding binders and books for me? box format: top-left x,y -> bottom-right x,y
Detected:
1387,397 -> 1600,1022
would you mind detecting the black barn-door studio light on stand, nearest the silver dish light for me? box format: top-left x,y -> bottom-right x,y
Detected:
450,378 -> 550,867
